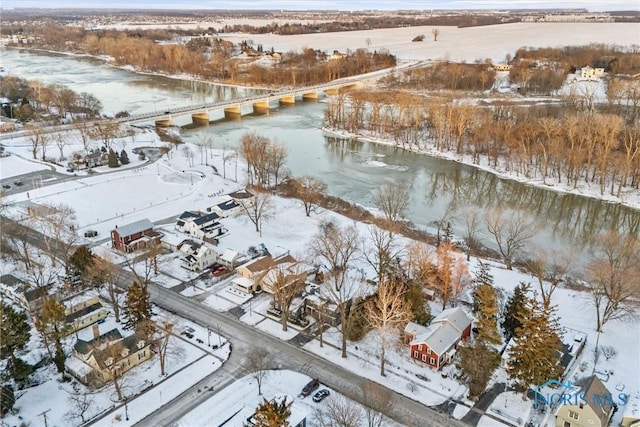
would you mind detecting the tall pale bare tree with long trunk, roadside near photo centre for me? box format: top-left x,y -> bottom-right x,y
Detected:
309,223 -> 360,358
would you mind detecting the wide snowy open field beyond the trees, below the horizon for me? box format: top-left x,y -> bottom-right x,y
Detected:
95,19 -> 640,62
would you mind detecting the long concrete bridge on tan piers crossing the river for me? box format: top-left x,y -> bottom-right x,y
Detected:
120,62 -> 425,127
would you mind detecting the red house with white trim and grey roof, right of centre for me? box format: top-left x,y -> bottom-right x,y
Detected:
405,307 -> 471,369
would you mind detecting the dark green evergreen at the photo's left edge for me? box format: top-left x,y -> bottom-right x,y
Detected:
0,302 -> 32,382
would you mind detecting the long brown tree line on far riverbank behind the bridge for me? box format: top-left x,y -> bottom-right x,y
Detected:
11,23 -> 396,86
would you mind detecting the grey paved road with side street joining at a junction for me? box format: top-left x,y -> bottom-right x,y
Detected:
1,217 -> 465,427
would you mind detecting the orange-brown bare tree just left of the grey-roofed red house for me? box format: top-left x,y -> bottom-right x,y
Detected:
364,279 -> 411,377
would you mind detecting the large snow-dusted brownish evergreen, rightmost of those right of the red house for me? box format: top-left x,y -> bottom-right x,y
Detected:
507,293 -> 562,391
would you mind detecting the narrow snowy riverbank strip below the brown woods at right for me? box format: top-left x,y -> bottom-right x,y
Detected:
322,127 -> 640,211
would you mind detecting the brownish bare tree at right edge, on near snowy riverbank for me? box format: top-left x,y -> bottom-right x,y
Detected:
586,231 -> 640,332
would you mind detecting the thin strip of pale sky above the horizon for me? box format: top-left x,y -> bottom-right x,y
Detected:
8,0 -> 640,11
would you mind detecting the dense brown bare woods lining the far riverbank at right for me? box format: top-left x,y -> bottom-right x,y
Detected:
325,91 -> 640,196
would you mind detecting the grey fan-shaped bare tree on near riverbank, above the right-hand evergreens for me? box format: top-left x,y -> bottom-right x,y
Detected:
486,209 -> 537,270
